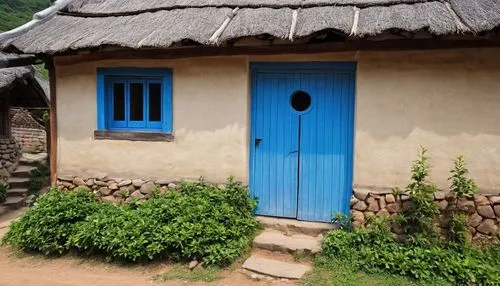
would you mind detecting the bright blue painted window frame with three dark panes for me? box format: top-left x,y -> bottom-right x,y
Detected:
97,68 -> 172,132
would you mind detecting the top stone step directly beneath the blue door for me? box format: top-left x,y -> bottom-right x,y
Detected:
257,216 -> 337,236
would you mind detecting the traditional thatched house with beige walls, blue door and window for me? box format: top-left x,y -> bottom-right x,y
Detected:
0,0 -> 500,221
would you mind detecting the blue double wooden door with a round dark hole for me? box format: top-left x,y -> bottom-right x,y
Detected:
250,62 -> 356,221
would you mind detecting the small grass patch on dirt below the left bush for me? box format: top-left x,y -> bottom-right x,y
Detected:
156,264 -> 223,282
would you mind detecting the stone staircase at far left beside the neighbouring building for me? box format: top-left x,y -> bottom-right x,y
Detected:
3,154 -> 47,210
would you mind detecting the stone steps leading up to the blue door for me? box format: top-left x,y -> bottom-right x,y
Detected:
242,217 -> 334,280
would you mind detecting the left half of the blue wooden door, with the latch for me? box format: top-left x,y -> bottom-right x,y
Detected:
250,73 -> 300,217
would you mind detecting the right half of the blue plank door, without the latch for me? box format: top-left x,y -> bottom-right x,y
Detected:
297,72 -> 354,221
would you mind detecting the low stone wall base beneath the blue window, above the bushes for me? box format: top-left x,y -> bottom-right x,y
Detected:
57,176 -> 177,204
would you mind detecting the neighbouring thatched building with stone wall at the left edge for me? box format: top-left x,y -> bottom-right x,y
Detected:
0,59 -> 48,177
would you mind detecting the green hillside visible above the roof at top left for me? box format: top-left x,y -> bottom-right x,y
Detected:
0,0 -> 51,31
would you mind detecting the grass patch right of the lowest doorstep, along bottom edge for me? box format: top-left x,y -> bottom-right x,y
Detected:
301,256 -> 451,286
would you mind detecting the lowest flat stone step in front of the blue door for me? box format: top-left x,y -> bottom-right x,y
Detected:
242,255 -> 311,279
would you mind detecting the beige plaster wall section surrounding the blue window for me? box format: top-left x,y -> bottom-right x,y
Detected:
57,58 -> 248,181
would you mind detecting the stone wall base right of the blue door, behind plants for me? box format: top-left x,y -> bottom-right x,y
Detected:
350,189 -> 500,239
